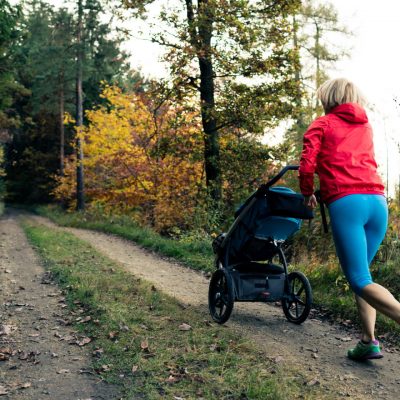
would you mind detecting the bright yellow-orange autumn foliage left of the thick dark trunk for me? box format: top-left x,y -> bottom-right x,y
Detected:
55,86 -> 203,230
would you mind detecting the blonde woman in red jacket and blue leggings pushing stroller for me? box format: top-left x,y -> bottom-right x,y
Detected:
299,79 -> 400,360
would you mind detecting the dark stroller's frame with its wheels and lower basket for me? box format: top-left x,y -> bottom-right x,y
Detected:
208,165 -> 313,324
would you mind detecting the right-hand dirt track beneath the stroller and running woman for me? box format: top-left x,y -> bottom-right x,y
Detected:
25,217 -> 400,400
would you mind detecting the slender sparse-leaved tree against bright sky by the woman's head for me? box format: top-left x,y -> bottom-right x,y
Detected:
286,0 -> 351,160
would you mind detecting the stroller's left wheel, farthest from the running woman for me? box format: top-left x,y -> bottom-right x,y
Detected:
208,268 -> 235,324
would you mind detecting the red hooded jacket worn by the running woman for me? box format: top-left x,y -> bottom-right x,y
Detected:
299,103 -> 384,203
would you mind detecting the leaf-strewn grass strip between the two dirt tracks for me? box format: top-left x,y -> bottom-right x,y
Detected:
23,222 -> 321,400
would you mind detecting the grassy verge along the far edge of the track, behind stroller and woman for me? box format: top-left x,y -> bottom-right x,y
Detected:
36,207 -> 400,343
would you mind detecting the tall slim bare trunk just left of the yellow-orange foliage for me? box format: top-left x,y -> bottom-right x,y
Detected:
76,0 -> 85,211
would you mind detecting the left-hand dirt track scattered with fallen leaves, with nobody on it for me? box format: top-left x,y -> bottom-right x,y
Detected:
0,214 -> 119,400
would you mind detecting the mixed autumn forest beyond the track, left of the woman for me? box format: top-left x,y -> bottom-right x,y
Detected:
0,0 -> 350,228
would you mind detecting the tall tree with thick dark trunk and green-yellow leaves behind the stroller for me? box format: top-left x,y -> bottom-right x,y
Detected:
123,0 -> 300,203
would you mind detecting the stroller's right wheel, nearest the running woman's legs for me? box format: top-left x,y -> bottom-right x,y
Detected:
282,271 -> 312,324
